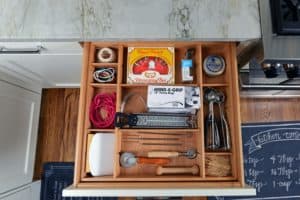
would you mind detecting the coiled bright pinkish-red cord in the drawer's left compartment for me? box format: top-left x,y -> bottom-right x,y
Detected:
90,93 -> 116,128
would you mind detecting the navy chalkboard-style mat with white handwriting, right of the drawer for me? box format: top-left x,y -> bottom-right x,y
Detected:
208,122 -> 300,200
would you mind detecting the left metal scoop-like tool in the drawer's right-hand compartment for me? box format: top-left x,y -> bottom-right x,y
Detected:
204,88 -> 220,150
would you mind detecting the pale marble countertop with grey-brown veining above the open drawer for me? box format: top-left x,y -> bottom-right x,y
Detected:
0,0 -> 261,41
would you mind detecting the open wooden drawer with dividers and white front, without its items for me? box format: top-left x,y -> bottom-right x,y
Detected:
64,41 -> 255,196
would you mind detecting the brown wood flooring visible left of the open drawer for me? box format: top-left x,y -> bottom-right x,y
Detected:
34,89 -> 80,180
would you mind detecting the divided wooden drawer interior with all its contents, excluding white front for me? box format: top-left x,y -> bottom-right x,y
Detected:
74,42 -> 244,188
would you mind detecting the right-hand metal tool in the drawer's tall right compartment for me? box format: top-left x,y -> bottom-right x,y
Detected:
217,91 -> 231,151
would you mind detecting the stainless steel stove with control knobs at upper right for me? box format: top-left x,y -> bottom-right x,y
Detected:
240,0 -> 300,89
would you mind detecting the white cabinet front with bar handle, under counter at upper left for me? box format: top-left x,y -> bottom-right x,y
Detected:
0,42 -> 82,88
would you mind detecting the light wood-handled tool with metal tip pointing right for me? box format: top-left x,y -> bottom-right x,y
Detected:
148,149 -> 198,159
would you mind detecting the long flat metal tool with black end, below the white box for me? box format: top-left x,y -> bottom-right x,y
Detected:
115,113 -> 197,128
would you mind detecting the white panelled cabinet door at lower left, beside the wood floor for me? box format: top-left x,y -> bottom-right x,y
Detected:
0,81 -> 41,194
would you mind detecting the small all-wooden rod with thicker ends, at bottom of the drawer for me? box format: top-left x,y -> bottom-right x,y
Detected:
156,165 -> 199,175
